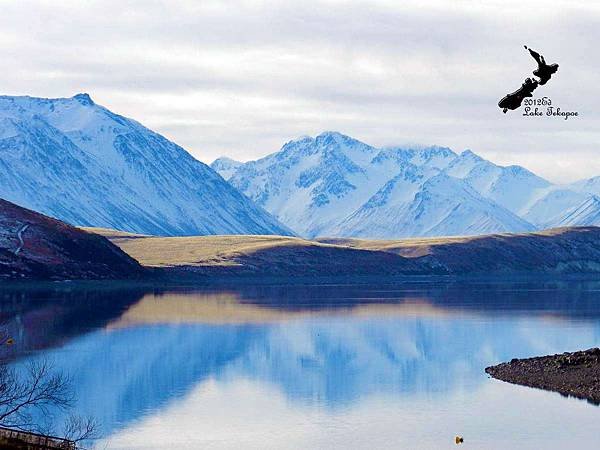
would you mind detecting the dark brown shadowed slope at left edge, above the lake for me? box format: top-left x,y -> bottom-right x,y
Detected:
0,199 -> 143,279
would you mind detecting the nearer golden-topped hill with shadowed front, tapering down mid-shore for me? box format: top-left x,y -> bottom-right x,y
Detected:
86,228 -> 423,276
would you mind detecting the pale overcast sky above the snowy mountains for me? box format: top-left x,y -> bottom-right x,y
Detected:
0,0 -> 600,182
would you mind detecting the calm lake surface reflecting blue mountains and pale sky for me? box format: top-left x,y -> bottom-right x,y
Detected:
0,281 -> 600,449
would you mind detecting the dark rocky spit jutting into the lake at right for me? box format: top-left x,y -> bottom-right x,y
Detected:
485,348 -> 600,405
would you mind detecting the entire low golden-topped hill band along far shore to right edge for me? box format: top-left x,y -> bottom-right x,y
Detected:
86,227 -> 600,277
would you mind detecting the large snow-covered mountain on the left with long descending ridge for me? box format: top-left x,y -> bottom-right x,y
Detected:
0,94 -> 291,235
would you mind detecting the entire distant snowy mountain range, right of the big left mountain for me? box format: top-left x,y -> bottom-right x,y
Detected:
212,132 -> 600,238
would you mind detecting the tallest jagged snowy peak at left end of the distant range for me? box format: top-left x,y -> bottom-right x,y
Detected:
218,133 -> 382,236
